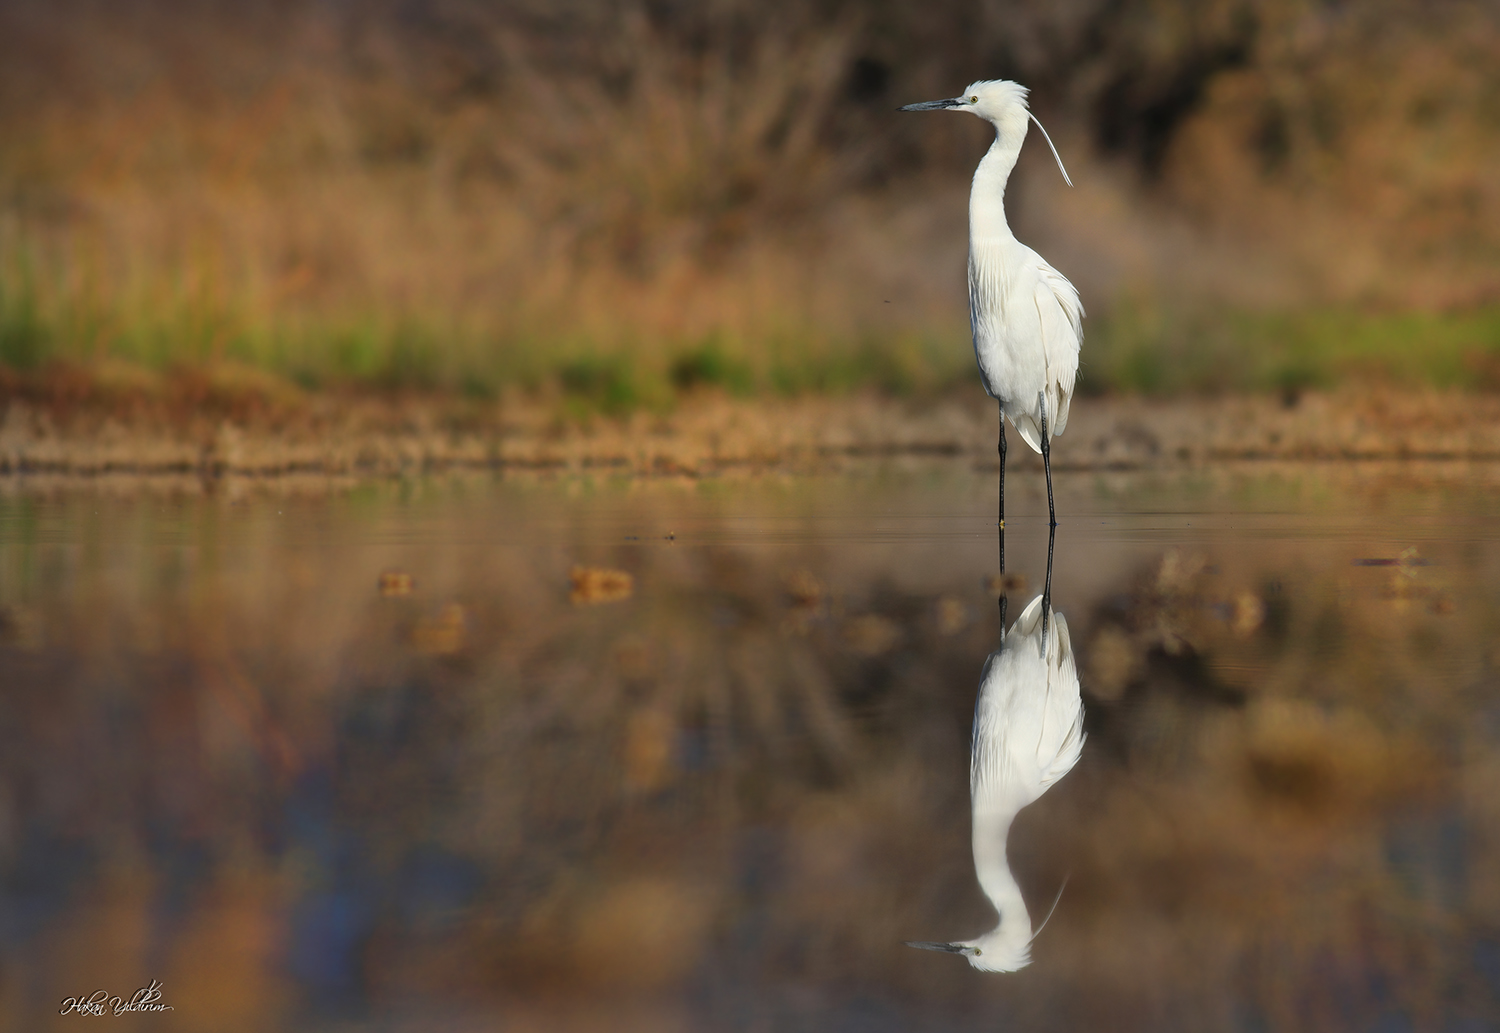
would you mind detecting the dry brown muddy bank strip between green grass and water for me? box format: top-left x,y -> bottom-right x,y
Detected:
0,391 -> 1500,477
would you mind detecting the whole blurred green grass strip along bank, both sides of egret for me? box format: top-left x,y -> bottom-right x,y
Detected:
0,245 -> 1500,418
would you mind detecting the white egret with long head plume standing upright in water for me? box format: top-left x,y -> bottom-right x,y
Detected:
902,79 -> 1083,530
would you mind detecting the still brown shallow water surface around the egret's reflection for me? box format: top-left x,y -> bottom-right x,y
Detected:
0,460 -> 1500,1030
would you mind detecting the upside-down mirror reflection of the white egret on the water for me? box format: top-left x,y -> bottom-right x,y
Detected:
906,529 -> 1085,972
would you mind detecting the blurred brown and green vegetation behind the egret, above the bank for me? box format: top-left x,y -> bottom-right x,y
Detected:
0,0 -> 1500,401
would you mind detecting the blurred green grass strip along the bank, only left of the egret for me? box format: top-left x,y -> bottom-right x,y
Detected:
0,247 -> 974,407
